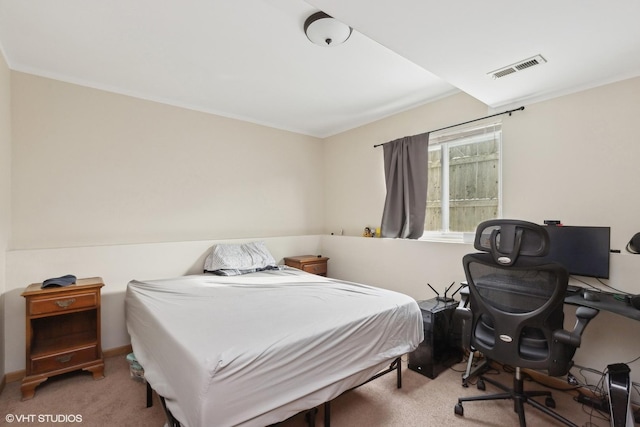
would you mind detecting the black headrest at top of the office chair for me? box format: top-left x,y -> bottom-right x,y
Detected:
473,219 -> 549,266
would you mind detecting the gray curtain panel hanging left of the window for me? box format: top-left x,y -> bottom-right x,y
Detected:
380,133 -> 429,239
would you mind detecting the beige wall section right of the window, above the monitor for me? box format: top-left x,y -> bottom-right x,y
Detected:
503,78 -> 640,242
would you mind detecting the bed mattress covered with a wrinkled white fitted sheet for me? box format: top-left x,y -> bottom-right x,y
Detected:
126,268 -> 423,427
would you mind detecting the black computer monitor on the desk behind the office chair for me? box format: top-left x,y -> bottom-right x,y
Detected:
545,225 -> 611,279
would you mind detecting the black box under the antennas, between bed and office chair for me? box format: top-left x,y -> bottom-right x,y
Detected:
407,298 -> 462,379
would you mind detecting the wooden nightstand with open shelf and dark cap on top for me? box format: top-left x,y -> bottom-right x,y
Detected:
21,277 -> 104,400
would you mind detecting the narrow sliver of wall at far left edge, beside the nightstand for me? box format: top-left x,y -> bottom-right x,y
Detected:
0,49 -> 11,381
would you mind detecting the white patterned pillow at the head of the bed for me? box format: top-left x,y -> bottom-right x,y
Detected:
204,242 -> 276,275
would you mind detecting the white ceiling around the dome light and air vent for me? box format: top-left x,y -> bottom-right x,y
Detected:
0,0 -> 640,137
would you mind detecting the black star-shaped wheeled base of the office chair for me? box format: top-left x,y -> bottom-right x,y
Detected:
454,368 -> 577,427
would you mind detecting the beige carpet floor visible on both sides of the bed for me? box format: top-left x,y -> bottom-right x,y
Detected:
0,356 -> 609,427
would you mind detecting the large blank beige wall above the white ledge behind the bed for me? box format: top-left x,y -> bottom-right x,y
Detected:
11,72 -> 324,249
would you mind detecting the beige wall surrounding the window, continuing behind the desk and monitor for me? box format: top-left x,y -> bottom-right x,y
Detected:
323,78 -> 640,388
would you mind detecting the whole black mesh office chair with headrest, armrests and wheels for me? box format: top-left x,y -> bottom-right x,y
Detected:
455,219 -> 598,427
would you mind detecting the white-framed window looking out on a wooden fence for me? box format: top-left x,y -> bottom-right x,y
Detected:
423,123 -> 502,238
